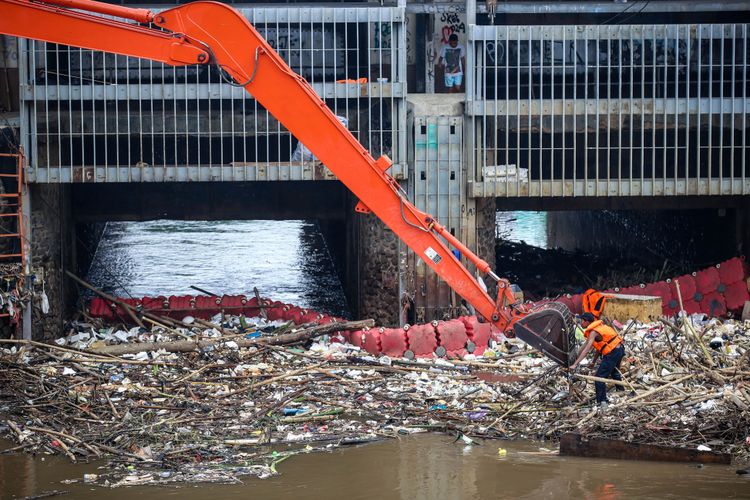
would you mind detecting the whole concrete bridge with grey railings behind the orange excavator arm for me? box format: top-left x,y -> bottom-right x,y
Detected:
4,0 -> 750,338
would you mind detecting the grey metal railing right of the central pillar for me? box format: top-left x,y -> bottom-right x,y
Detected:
467,24 -> 750,197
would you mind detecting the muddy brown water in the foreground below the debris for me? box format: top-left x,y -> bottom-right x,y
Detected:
0,435 -> 750,500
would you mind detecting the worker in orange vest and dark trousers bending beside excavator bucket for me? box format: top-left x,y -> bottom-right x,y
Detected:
570,312 -> 625,408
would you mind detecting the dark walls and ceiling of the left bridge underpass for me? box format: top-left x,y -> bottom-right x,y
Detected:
27,181 -> 400,338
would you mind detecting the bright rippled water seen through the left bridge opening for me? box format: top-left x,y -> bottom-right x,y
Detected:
89,220 -> 348,316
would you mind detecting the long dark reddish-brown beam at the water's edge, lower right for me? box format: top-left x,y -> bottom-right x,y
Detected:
560,432 -> 732,464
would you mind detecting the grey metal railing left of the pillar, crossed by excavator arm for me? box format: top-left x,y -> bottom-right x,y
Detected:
19,6 -> 406,182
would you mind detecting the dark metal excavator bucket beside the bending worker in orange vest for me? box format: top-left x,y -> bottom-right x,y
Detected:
513,302 -> 577,368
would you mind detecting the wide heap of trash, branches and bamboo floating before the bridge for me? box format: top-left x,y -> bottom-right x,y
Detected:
0,315 -> 750,487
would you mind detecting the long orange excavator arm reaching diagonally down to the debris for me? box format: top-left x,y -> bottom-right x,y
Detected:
0,0 -> 576,364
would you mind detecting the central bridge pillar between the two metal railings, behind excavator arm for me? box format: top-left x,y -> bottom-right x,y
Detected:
321,94 -> 495,326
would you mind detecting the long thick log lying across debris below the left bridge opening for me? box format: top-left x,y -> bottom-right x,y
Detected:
91,319 -> 375,356
